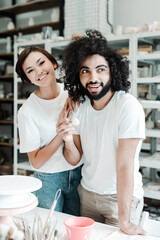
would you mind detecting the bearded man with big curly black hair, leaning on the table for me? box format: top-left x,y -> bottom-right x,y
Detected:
57,30 -> 145,235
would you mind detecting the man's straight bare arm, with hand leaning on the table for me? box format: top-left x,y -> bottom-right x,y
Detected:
116,138 -> 145,235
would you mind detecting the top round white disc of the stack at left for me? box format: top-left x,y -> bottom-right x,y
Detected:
0,175 -> 42,195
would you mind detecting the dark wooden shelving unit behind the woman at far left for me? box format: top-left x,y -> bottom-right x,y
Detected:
0,0 -> 64,174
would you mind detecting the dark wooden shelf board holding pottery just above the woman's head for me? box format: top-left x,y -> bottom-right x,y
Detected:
0,22 -> 60,38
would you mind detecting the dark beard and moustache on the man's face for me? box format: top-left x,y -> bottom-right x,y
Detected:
82,80 -> 111,101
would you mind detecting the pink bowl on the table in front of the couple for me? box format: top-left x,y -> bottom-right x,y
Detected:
64,217 -> 94,240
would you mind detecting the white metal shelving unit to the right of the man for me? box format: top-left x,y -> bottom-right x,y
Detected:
134,32 -> 160,200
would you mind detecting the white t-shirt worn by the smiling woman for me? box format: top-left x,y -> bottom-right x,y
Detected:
18,84 -> 81,173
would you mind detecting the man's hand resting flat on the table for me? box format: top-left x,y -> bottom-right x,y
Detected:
120,223 -> 147,235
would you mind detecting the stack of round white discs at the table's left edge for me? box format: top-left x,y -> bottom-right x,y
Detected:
0,175 -> 42,216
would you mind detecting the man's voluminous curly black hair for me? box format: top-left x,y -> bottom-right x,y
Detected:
62,29 -> 130,101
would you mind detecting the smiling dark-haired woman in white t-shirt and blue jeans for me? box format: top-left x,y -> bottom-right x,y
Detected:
16,46 -> 81,216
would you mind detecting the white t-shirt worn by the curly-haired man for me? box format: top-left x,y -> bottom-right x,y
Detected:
74,91 -> 145,198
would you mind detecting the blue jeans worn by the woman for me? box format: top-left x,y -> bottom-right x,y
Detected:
34,166 -> 81,216
